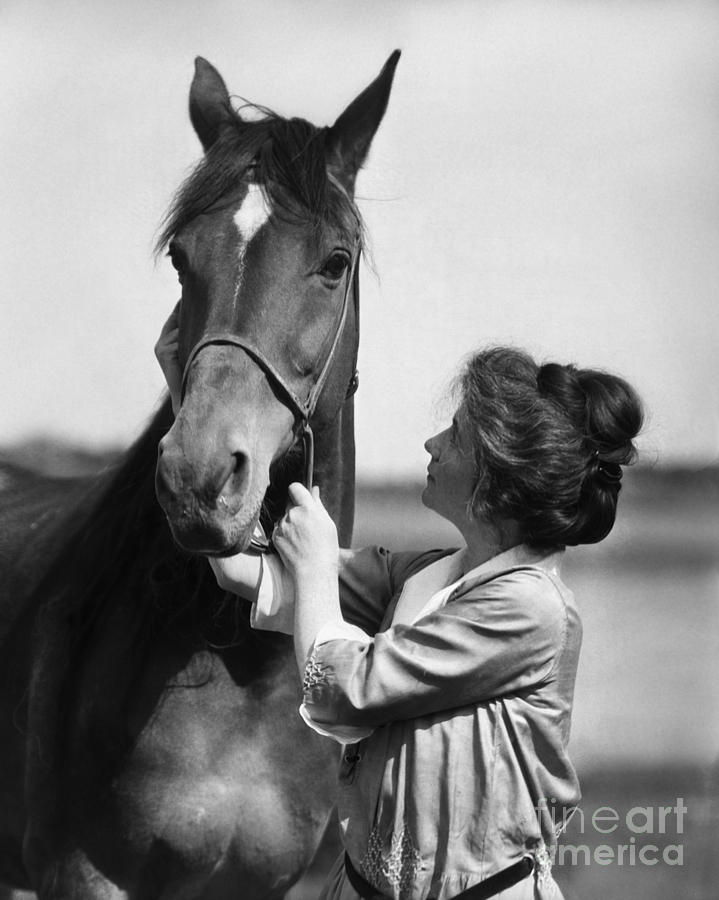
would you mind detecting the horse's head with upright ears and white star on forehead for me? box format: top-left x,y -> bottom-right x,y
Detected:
156,52 -> 399,554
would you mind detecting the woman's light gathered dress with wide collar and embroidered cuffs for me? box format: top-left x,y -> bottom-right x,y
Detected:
252,546 -> 581,900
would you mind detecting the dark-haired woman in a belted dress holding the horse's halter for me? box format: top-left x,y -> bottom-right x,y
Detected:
156,329 -> 642,900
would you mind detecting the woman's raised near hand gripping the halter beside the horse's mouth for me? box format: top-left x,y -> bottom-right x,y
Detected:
272,482 -> 339,582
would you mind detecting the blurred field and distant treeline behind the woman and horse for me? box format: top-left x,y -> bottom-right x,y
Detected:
0,441 -> 719,900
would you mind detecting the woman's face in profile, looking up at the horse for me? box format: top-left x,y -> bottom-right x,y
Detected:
422,407 -> 477,531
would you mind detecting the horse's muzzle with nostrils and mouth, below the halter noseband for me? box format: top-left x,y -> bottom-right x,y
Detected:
155,345 -> 295,554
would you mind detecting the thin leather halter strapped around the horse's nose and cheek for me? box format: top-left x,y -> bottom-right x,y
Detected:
181,250 -> 359,553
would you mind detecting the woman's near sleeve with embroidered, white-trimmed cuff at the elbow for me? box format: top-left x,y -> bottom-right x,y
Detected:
302,568 -> 567,742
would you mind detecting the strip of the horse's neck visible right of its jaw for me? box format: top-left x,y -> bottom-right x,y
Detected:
314,397 -> 355,547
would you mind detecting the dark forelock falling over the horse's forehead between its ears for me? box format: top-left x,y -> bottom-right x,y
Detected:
156,104 -> 364,253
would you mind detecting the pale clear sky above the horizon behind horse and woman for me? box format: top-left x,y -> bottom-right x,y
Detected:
0,0 -> 719,478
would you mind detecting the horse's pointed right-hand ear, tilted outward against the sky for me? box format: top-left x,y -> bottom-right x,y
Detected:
326,50 -> 400,191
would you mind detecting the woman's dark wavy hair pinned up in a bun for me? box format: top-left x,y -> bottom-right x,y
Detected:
457,347 -> 643,547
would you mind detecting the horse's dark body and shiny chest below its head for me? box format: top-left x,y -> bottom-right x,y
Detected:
0,401 -> 340,900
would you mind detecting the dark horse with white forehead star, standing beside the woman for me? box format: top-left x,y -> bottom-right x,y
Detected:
0,52 -> 399,900
